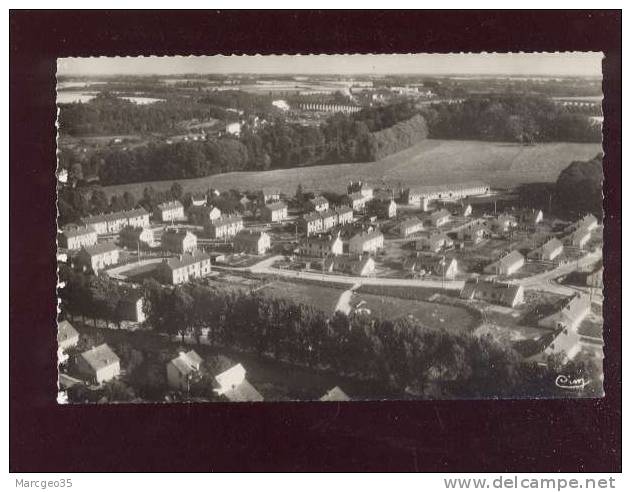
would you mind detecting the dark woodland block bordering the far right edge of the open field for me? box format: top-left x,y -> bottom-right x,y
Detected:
423,95 -> 602,143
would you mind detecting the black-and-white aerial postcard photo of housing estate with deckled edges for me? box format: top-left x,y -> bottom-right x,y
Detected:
56,53 -> 604,403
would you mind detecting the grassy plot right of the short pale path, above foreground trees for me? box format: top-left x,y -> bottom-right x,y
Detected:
352,293 -> 476,332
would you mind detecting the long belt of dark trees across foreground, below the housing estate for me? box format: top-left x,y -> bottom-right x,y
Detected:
60,269 -> 598,398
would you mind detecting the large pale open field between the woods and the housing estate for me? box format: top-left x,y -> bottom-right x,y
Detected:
104,140 -> 602,197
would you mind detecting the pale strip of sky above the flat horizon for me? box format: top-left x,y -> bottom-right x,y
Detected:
57,52 -> 602,76
